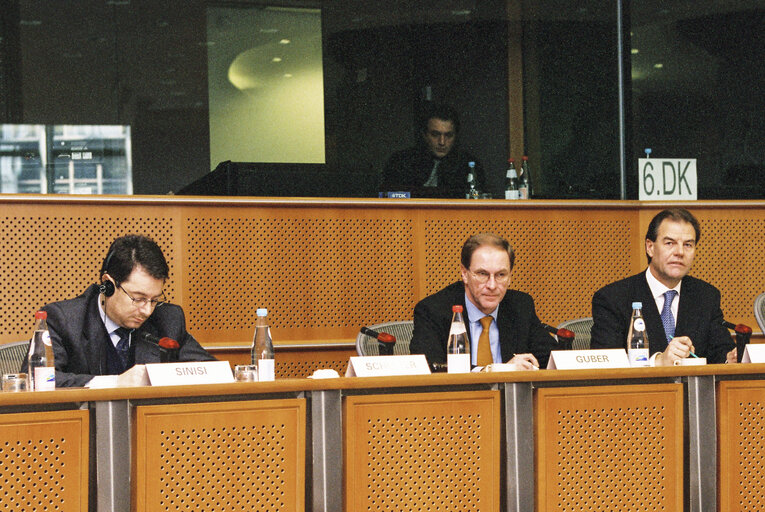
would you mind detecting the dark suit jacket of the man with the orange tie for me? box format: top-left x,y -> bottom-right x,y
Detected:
410,281 -> 556,368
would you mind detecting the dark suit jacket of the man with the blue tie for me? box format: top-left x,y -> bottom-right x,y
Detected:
590,272 -> 736,363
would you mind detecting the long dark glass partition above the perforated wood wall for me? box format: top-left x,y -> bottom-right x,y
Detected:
0,0 -> 765,199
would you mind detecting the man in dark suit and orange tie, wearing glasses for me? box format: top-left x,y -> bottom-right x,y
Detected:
410,234 -> 555,370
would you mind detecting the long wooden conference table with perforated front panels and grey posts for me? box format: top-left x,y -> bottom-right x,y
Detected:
0,364 -> 765,512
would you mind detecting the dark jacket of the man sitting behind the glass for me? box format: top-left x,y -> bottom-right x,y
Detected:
379,144 -> 486,199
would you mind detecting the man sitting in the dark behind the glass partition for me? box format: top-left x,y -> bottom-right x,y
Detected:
380,104 -> 486,199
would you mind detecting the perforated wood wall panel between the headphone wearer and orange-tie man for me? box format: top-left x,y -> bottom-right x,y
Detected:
185,214 -> 415,341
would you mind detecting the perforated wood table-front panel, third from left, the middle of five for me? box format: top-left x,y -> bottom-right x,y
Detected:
343,391 -> 500,512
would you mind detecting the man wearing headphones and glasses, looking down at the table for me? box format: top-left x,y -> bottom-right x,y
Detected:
22,235 -> 215,387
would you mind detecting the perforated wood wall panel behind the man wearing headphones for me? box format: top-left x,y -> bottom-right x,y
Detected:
0,205 -> 178,341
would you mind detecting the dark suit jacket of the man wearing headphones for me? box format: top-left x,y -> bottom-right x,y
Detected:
25,285 -> 215,387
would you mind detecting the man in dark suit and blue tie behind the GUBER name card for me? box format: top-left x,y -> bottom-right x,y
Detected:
591,208 -> 736,366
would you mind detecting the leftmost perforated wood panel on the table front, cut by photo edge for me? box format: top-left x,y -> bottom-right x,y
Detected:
0,410 -> 88,512
